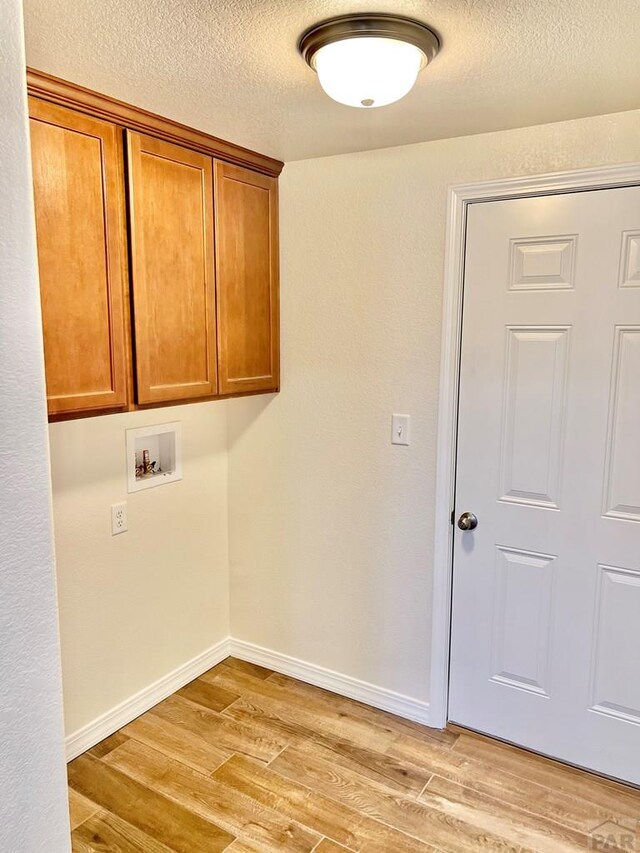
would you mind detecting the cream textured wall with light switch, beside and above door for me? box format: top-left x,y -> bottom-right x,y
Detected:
229,106 -> 640,701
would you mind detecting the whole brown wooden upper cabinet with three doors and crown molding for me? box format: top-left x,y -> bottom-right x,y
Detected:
27,70 -> 283,418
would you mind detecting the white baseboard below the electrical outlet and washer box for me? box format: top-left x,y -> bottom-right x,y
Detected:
65,637 -> 231,761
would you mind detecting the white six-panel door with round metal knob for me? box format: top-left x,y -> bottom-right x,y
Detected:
449,187 -> 640,784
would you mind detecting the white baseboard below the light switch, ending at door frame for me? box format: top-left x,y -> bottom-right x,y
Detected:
229,638 -> 429,726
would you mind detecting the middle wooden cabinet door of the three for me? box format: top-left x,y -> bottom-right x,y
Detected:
127,131 -> 217,404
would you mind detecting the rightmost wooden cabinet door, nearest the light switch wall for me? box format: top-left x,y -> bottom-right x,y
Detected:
215,162 -> 280,394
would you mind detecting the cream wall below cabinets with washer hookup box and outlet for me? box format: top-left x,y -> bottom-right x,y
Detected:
49,402 -> 229,735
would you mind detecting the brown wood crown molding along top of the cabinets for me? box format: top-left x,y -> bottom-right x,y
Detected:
27,68 -> 284,177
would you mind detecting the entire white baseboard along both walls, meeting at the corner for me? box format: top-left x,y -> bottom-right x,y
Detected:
65,637 -> 429,761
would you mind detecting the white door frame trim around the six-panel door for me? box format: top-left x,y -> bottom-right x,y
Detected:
429,163 -> 640,728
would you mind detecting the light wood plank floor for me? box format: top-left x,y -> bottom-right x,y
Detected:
69,658 -> 640,853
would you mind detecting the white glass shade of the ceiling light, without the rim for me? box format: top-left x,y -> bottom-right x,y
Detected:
313,36 -> 425,107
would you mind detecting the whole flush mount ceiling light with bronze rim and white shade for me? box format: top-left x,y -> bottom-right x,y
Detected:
298,14 -> 440,108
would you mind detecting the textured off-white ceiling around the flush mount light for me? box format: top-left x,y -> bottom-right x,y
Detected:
25,0 -> 640,160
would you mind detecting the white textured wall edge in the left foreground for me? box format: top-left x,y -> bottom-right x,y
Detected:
0,0 -> 70,853
